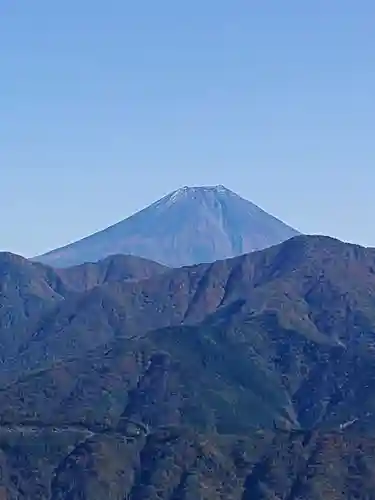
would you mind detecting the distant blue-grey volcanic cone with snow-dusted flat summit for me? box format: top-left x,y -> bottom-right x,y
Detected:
34,186 -> 299,267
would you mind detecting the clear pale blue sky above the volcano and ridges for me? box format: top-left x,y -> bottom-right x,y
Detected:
0,0 -> 375,256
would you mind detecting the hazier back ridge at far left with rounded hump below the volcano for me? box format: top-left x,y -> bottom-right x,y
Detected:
0,253 -> 166,359
